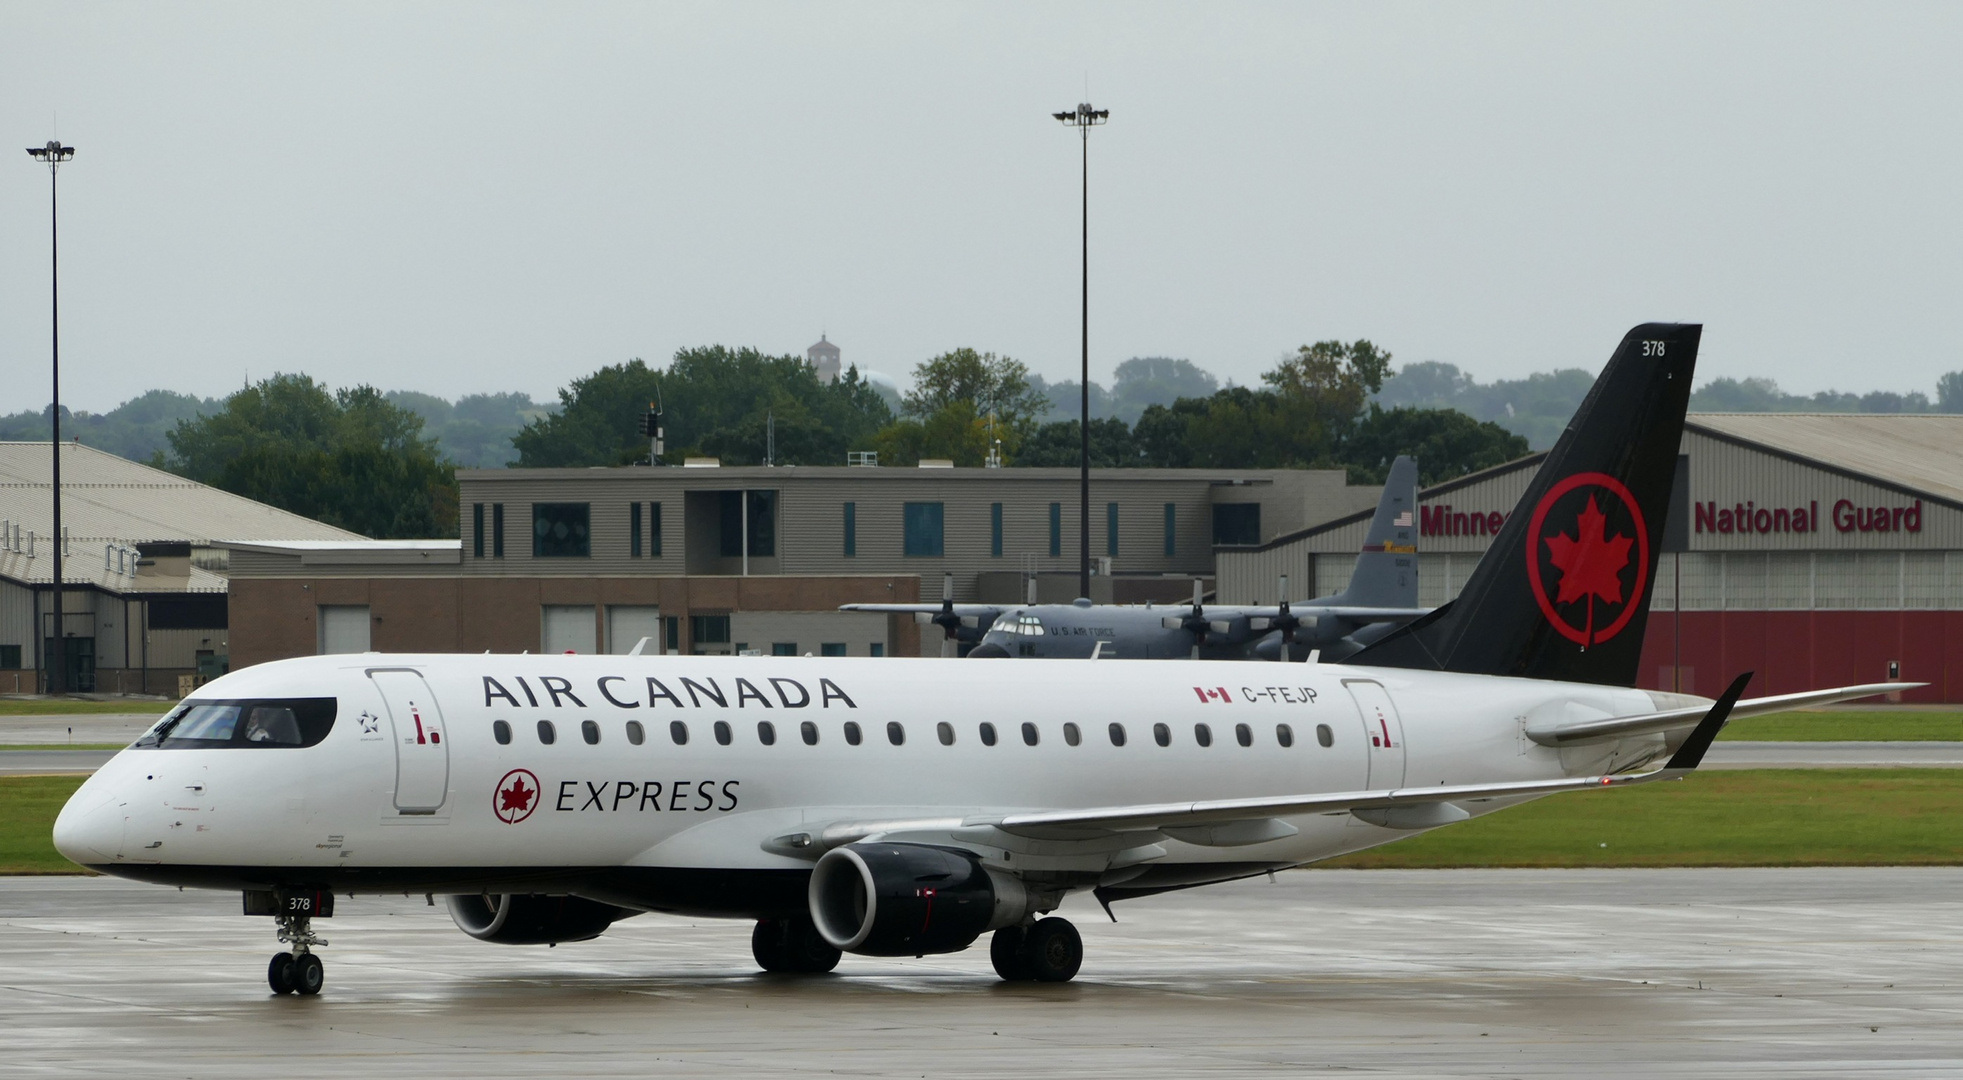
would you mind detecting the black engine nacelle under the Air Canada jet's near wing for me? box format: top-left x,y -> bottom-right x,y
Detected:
811,842 -> 1031,956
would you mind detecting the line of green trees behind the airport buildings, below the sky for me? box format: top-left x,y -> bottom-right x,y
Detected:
0,340 -> 1963,538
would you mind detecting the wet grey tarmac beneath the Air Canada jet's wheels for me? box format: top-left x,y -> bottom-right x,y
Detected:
0,868 -> 1963,1078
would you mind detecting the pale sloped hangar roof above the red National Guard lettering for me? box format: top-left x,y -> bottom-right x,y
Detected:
1684,412 -> 1963,503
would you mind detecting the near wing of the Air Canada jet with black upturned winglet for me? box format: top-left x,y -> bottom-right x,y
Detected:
771,674 -> 1750,858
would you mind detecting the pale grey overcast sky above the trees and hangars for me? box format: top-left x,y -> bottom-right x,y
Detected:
0,0 -> 1963,410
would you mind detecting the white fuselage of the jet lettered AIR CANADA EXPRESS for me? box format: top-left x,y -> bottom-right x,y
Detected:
55,654 -> 1663,915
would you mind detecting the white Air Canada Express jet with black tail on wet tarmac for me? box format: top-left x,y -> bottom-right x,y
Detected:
55,324 -> 1908,994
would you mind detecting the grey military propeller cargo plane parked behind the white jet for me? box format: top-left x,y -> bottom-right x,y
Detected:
840,456 -> 1429,660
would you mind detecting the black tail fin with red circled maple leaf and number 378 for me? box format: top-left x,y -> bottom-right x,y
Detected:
1345,322 -> 1704,685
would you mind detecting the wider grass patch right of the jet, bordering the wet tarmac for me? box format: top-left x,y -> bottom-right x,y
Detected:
1321,768 -> 1963,868
